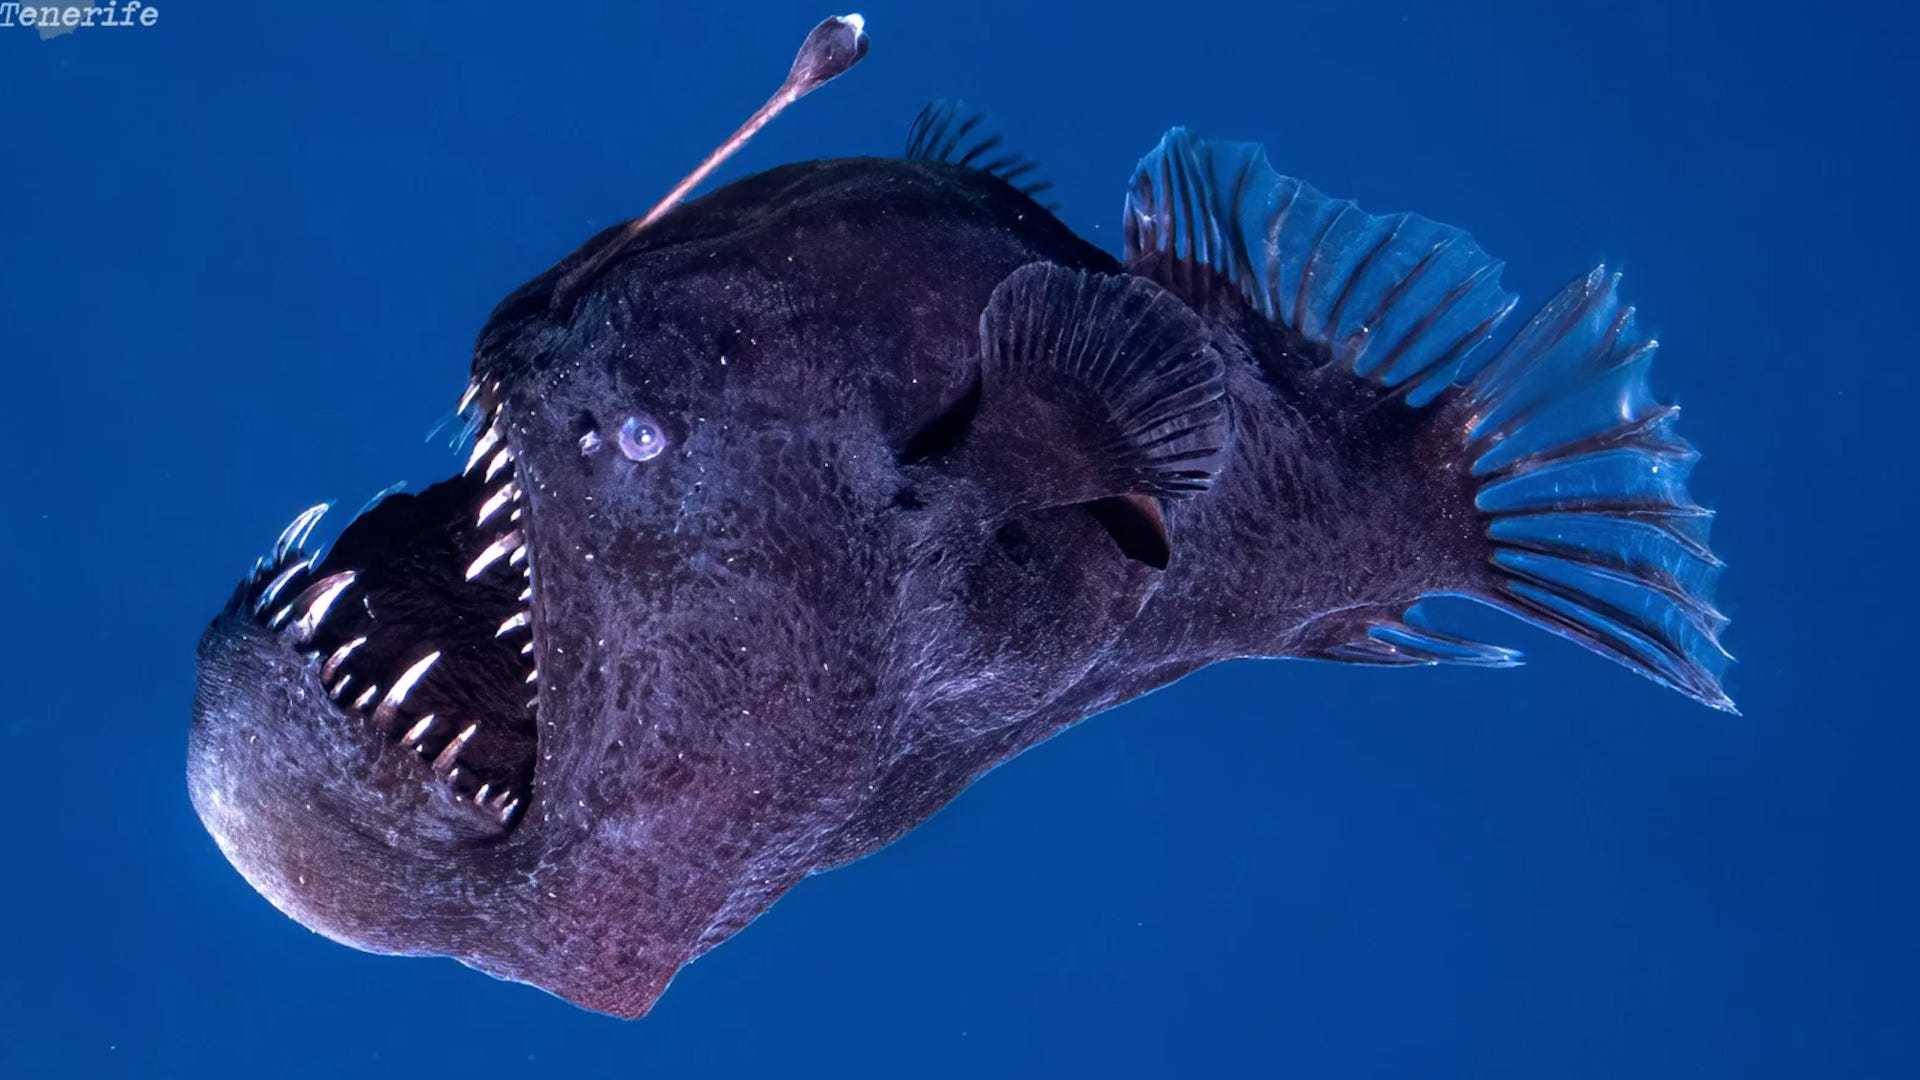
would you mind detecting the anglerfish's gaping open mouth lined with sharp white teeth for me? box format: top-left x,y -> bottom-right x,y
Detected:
236,388 -> 540,828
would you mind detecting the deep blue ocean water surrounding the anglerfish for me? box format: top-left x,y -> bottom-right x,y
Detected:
0,0 -> 1920,1080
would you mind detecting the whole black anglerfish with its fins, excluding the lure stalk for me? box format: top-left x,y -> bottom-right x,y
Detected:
188,56 -> 1730,1017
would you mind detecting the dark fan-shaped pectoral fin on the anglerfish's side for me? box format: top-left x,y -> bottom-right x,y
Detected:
950,263 -> 1231,509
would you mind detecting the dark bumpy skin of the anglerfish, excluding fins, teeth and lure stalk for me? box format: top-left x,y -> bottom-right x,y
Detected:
190,160 -> 1574,1017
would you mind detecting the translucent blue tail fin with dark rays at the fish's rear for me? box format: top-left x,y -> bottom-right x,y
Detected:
1448,267 -> 1734,709
